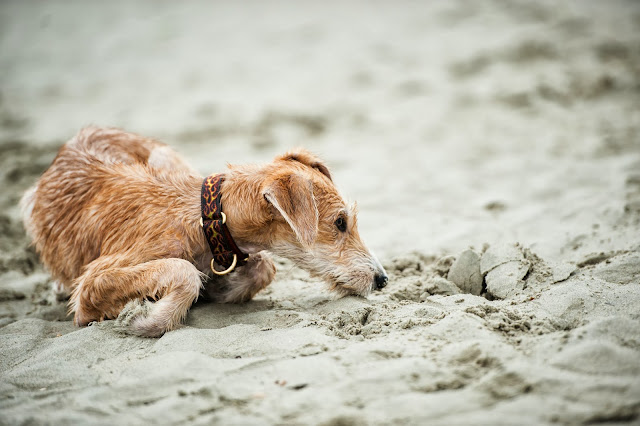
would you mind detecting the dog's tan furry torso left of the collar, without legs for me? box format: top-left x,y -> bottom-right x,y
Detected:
22,128 -> 198,289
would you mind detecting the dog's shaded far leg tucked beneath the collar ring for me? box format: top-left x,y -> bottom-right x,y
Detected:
205,252 -> 276,303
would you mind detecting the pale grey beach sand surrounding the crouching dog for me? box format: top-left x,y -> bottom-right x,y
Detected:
0,1 -> 640,425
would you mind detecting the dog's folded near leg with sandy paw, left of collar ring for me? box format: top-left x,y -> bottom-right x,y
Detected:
70,256 -> 203,337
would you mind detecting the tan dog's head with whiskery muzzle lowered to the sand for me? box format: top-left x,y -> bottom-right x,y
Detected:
262,150 -> 387,296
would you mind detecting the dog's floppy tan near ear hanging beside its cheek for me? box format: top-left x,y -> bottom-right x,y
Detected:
262,173 -> 318,247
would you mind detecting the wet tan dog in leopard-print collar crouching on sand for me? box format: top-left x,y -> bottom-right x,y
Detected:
21,127 -> 388,337
